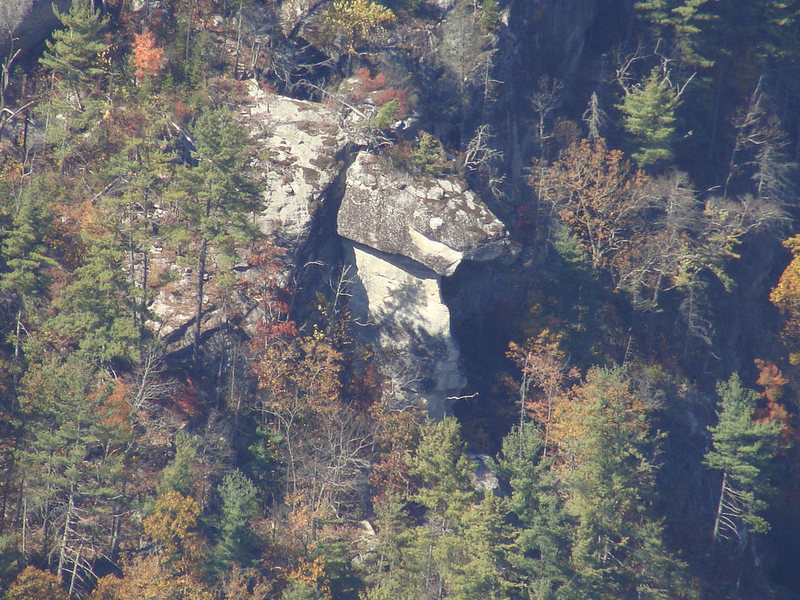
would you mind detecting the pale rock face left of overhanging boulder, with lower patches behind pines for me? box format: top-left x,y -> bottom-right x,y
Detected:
149,81 -> 349,350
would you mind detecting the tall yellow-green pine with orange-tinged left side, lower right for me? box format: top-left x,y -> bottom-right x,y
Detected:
553,368 -> 693,600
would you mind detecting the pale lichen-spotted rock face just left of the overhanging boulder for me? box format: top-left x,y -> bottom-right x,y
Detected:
243,82 -> 350,246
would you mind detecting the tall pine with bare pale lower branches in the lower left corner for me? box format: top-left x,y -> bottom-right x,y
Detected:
19,356 -> 131,593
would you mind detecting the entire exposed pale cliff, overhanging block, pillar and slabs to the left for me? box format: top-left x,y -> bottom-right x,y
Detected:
145,83 -> 506,417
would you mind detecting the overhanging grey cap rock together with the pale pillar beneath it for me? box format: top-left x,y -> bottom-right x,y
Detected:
338,152 -> 507,417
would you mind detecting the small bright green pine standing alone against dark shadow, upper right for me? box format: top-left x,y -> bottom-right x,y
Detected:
619,68 -> 678,167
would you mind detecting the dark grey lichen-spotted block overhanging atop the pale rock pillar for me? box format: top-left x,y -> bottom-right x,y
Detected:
338,152 -> 507,276
